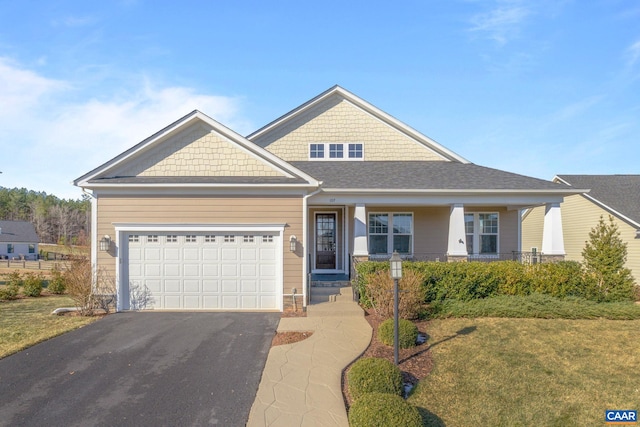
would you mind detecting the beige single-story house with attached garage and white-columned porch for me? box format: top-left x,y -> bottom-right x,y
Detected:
74,86 -> 581,310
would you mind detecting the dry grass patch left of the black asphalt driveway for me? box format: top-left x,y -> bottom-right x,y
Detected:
0,296 -> 99,358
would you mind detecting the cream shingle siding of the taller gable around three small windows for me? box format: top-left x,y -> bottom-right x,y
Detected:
253,95 -> 447,162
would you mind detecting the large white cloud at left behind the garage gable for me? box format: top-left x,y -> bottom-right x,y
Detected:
0,58 -> 252,198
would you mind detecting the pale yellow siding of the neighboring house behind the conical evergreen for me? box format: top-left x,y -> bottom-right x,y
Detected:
562,195 -> 640,283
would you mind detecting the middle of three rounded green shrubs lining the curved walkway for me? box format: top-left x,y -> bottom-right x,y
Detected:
347,357 -> 402,401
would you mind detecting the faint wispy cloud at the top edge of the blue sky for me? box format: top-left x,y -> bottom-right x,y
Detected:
470,1 -> 532,45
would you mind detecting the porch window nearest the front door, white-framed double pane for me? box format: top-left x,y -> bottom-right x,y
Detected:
369,213 -> 413,255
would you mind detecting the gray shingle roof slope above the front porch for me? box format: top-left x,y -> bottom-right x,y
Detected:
291,161 -> 570,191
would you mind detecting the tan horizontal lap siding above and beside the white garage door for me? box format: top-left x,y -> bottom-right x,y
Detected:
97,197 -> 302,293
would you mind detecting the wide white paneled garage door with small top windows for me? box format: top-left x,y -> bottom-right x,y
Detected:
122,232 -> 282,310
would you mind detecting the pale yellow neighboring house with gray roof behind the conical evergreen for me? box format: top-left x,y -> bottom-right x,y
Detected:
522,175 -> 640,283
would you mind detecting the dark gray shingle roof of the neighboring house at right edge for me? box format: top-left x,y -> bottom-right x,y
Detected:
558,175 -> 640,224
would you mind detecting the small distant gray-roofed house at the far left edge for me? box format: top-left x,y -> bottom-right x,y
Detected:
0,221 -> 40,260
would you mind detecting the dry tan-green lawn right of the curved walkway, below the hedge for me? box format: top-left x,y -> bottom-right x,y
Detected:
409,318 -> 640,427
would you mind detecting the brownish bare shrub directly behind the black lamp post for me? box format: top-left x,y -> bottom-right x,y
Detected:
366,269 -> 425,319
